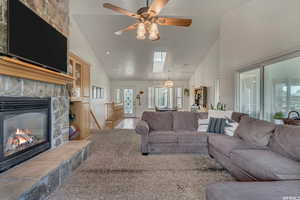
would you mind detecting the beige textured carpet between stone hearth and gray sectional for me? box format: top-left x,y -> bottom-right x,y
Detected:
49,130 -> 233,200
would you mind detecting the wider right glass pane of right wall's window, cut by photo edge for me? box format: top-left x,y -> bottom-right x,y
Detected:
264,57 -> 300,120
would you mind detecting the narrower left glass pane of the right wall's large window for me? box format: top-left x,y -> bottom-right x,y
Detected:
239,69 -> 261,118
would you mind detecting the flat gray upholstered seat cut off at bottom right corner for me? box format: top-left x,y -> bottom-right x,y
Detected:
206,181 -> 300,200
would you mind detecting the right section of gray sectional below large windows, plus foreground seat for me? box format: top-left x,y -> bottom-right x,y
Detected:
206,117 -> 300,200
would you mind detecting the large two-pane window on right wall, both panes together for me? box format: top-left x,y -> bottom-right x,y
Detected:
237,54 -> 300,121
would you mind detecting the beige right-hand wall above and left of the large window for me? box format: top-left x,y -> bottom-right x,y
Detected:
220,0 -> 300,108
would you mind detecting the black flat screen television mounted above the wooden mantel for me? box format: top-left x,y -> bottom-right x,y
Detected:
8,0 -> 68,73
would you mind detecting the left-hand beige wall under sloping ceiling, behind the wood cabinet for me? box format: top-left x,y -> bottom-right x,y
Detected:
70,17 -> 110,127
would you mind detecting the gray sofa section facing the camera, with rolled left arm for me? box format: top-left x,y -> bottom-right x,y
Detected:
135,112 -> 243,155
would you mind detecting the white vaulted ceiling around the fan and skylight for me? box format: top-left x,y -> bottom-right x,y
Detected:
70,0 -> 250,80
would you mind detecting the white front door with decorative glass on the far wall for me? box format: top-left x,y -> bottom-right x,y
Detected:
123,88 -> 136,117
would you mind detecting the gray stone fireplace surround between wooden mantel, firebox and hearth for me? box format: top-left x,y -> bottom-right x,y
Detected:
0,75 -> 69,148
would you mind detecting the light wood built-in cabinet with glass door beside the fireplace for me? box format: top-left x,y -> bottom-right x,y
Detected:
69,53 -> 91,139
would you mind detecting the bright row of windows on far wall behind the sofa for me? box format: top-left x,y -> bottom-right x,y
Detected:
148,87 -> 183,109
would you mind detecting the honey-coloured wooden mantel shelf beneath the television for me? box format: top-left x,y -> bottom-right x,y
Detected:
0,57 -> 74,85
